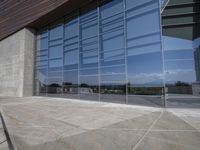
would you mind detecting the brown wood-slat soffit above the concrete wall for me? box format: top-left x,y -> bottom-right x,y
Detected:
0,0 -> 92,41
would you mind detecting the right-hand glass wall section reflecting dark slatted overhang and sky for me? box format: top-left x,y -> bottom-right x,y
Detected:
162,0 -> 200,107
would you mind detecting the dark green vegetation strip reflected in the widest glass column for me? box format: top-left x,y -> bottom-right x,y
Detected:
128,87 -> 162,95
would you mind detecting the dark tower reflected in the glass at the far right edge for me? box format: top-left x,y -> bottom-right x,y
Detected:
194,47 -> 200,81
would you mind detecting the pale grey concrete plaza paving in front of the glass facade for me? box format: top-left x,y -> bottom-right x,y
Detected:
0,97 -> 200,150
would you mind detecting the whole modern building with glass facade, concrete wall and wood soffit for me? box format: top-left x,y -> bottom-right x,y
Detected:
0,0 -> 200,106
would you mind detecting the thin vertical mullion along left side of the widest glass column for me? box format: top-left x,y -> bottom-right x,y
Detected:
123,0 -> 128,104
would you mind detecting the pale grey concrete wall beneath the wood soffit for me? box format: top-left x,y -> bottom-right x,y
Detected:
0,29 -> 35,97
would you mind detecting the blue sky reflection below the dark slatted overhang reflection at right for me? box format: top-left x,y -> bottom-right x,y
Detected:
163,36 -> 196,83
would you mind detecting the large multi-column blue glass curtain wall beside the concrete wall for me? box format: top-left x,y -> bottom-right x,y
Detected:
35,0 -> 164,106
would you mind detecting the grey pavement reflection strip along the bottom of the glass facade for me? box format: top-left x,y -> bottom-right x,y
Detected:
38,92 -> 200,108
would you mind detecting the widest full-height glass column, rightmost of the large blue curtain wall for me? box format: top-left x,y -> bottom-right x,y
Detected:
126,0 -> 164,107
